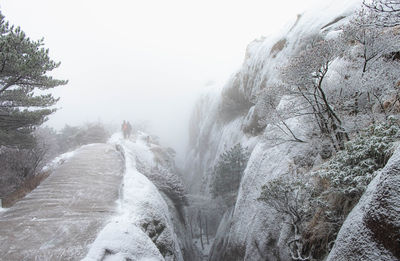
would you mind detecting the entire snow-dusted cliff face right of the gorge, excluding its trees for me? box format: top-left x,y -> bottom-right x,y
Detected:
185,0 -> 396,260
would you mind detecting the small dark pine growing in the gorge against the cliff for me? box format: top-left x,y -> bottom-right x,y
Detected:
211,143 -> 249,205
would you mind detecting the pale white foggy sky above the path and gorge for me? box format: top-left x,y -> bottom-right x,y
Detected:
0,0 -> 315,156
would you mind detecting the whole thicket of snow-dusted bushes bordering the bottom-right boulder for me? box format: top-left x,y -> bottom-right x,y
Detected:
259,117 -> 400,260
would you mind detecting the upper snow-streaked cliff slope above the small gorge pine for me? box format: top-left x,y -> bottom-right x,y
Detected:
186,0 -> 361,191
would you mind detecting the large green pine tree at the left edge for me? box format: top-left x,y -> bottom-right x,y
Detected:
0,13 -> 67,147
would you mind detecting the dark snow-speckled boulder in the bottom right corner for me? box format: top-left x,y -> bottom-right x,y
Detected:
327,145 -> 400,261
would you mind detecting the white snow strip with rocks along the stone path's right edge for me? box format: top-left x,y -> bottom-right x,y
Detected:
83,133 -> 183,261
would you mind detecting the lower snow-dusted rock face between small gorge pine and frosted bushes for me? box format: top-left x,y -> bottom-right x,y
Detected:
210,118 -> 309,261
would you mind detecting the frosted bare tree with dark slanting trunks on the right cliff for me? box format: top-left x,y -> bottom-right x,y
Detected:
283,37 -> 348,150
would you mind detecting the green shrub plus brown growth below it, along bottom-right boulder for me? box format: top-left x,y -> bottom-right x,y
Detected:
302,118 -> 400,260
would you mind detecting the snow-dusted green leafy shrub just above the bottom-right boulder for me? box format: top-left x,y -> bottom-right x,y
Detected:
314,118 -> 399,196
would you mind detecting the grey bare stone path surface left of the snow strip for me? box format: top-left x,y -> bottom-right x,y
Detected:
0,144 -> 124,261
